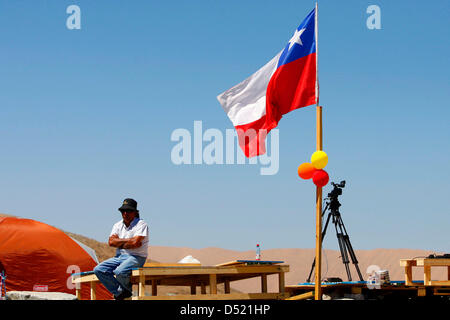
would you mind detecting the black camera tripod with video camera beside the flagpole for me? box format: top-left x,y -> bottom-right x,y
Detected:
306,181 -> 364,282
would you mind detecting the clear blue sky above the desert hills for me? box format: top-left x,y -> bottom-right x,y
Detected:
0,0 -> 450,252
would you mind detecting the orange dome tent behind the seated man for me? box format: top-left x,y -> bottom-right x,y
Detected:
0,217 -> 112,300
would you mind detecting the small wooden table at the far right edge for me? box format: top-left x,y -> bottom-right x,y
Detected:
400,258 -> 450,286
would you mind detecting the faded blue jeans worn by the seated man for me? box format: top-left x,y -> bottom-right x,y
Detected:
94,254 -> 147,296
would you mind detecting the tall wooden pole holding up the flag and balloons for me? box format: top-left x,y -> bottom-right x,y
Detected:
314,2 -> 323,300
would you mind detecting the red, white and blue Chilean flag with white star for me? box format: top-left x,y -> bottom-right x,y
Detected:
217,9 -> 319,157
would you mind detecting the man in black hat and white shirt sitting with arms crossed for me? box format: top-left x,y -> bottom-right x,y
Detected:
94,198 -> 148,300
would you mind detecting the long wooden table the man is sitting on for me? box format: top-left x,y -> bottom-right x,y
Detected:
72,261 -> 289,300
